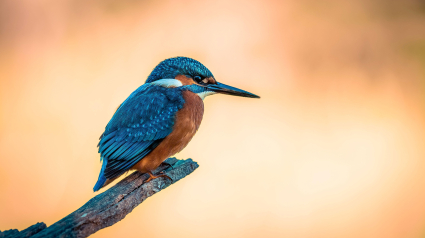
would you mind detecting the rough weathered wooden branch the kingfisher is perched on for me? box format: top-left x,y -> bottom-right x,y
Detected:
0,158 -> 199,238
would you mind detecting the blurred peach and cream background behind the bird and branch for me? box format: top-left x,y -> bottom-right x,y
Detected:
0,0 -> 425,238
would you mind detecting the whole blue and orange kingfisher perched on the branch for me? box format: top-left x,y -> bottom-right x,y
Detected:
93,57 -> 259,192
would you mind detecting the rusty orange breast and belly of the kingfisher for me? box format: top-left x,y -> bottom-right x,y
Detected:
133,91 -> 204,173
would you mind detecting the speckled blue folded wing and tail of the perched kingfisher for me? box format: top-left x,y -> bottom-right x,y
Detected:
93,84 -> 184,191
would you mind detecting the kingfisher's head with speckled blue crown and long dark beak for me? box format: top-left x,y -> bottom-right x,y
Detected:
146,57 -> 259,99
